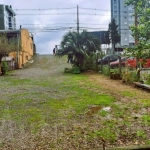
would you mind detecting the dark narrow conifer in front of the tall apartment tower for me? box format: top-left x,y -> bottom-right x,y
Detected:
108,19 -> 120,54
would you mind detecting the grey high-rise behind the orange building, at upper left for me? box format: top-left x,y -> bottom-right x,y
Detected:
0,5 -> 16,30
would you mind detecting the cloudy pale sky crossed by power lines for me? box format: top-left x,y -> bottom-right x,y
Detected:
0,0 -> 110,54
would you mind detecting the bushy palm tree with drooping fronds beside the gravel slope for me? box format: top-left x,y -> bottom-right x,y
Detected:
57,31 -> 101,70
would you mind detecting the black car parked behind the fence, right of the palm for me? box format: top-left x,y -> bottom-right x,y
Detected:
98,54 -> 120,65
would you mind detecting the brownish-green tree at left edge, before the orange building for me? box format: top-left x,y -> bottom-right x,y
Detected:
0,34 -> 18,63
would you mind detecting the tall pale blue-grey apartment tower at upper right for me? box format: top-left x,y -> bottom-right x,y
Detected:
111,0 -> 135,48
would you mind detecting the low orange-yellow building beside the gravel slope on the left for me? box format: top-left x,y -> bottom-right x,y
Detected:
0,28 -> 36,68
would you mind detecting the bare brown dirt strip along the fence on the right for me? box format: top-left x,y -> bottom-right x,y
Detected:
87,73 -> 150,100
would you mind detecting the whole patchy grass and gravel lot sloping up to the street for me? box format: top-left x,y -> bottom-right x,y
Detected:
0,55 -> 150,150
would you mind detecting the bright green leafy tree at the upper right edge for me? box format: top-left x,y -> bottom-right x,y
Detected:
125,0 -> 150,63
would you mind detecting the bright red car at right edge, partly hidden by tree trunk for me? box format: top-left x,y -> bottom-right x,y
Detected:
126,57 -> 150,68
